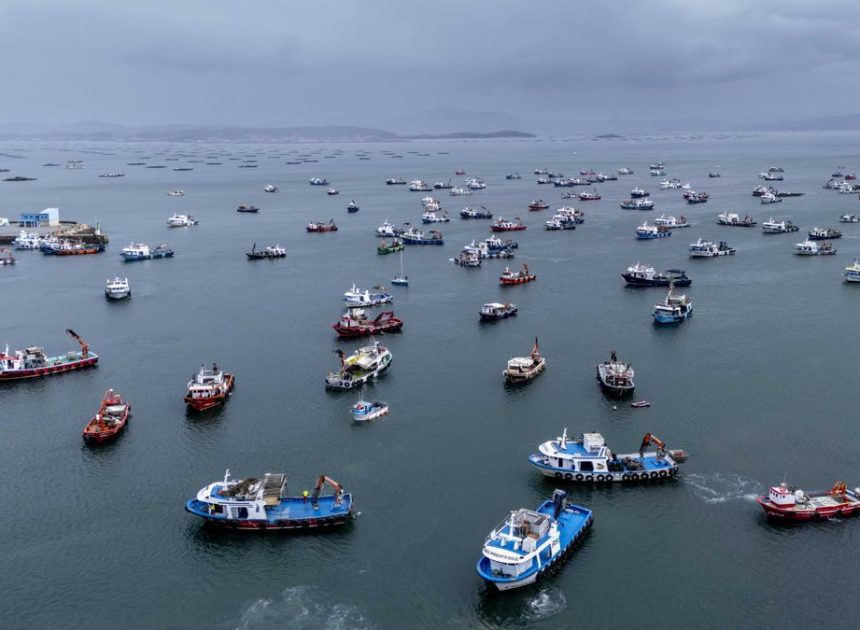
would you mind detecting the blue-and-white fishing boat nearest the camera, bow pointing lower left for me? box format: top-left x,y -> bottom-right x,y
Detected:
476,490 -> 594,591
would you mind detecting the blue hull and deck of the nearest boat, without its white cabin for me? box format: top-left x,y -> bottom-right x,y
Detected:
476,501 -> 594,590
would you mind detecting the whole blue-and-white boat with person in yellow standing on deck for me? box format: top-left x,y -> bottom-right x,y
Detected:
185,470 -> 353,532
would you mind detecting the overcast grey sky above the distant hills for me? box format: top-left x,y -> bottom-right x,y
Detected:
0,0 -> 860,130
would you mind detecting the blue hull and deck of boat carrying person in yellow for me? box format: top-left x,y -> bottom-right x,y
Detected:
185,494 -> 353,531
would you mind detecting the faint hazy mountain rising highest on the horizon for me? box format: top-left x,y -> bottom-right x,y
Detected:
380,107 -> 529,135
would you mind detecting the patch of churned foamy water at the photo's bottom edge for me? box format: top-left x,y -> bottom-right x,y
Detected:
236,586 -> 373,630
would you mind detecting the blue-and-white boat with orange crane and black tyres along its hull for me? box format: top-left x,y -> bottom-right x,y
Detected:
529,429 -> 687,483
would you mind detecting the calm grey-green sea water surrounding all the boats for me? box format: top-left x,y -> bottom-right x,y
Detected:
0,135 -> 860,629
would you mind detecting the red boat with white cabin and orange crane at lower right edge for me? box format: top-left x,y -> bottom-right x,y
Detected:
757,481 -> 860,521
